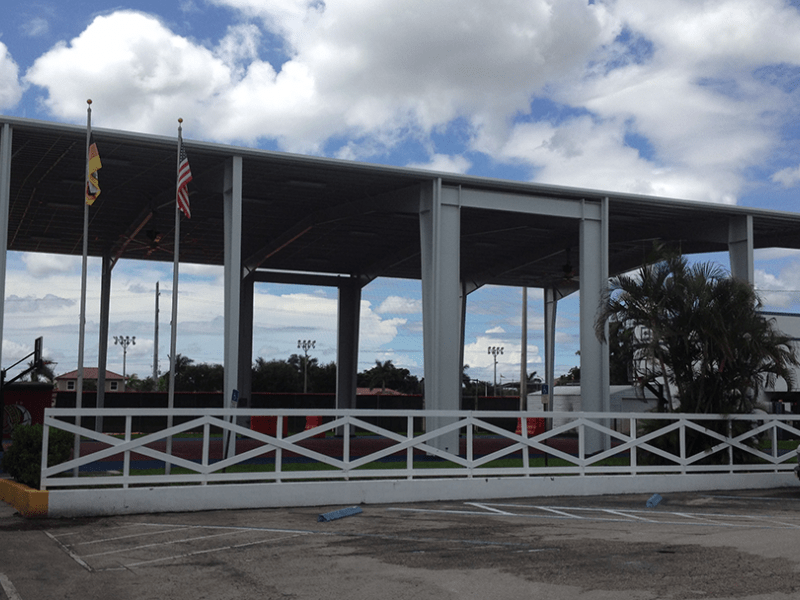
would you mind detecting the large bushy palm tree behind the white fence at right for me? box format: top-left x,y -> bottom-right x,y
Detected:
595,250 -> 800,414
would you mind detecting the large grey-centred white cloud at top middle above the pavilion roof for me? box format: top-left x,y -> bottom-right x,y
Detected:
209,0 -> 604,150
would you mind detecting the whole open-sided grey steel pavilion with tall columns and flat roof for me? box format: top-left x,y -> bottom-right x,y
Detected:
0,116 -> 800,447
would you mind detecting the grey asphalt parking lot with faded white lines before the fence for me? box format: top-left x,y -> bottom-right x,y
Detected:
0,487 -> 800,600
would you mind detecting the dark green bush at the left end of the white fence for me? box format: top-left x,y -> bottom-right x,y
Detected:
3,425 -> 74,490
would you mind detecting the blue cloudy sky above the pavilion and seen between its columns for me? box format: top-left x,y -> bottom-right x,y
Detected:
0,0 -> 800,380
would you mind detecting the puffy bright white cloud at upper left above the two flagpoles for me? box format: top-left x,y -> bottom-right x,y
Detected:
25,11 -> 231,132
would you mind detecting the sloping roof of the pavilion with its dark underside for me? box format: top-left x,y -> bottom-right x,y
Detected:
0,116 -> 800,287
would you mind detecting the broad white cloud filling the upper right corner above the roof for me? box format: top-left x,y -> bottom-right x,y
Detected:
476,0 -> 800,203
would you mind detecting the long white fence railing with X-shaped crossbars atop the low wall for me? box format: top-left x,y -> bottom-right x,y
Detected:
41,408 -> 800,489
